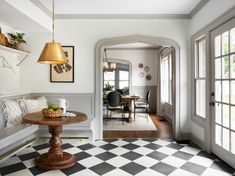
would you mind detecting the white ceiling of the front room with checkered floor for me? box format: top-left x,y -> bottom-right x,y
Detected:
34,0 -> 202,14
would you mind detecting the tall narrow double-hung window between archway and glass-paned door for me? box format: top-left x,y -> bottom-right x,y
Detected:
194,38 -> 206,118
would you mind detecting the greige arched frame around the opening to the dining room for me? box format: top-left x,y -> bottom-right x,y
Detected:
94,35 -> 180,140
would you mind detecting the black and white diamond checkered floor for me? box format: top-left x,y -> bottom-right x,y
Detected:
0,139 -> 234,176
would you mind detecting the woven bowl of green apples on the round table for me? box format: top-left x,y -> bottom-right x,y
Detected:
42,103 -> 63,118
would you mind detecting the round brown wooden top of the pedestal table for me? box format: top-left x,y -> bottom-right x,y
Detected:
22,111 -> 87,126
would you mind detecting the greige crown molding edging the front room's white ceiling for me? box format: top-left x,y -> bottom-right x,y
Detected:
30,0 -> 209,19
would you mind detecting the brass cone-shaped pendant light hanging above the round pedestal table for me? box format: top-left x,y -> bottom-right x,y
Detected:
38,0 -> 68,64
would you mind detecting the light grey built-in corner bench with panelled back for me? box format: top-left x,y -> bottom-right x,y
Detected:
0,93 -> 94,160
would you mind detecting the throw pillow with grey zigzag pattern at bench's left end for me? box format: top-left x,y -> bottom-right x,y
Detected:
2,99 -> 22,127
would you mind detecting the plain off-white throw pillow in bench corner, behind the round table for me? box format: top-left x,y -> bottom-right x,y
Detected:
24,96 -> 48,113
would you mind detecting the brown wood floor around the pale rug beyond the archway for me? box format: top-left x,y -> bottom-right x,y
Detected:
103,114 -> 173,139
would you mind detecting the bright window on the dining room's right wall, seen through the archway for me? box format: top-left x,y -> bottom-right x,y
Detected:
161,54 -> 172,104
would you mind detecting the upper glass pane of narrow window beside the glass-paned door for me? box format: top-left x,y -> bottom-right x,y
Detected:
198,40 -> 206,78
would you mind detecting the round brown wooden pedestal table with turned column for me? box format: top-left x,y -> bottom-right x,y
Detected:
23,111 -> 87,169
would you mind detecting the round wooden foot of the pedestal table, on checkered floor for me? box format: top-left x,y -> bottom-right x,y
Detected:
35,152 -> 76,169
